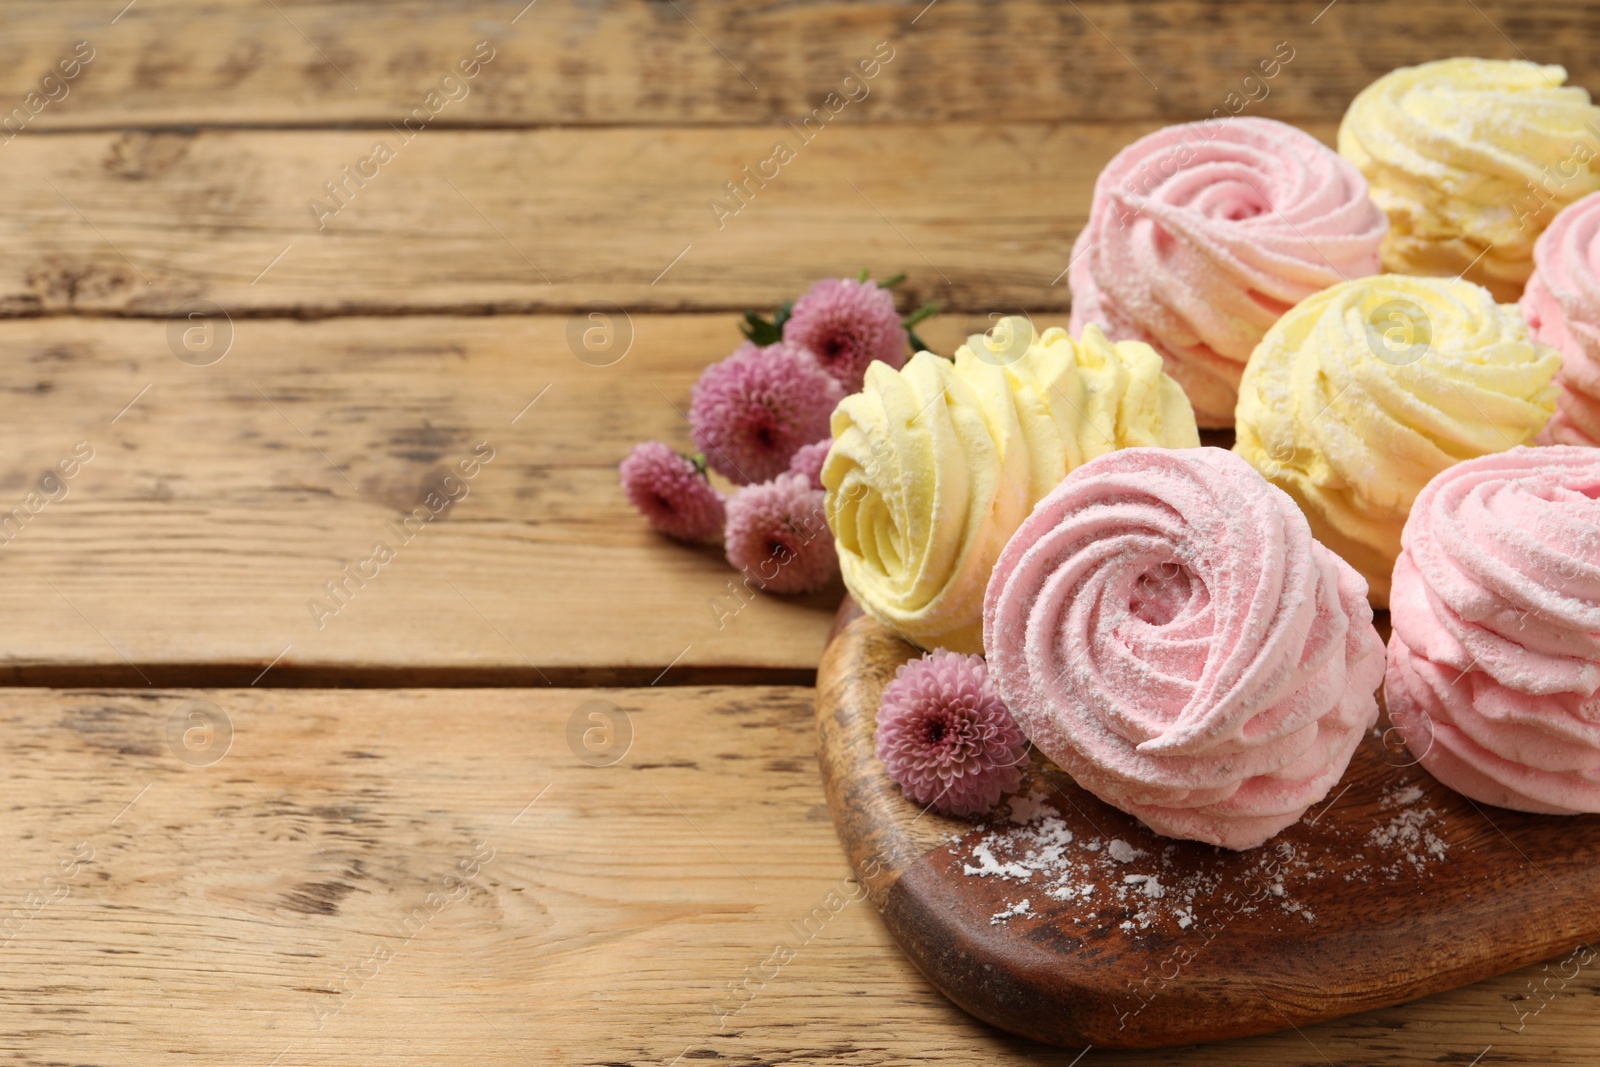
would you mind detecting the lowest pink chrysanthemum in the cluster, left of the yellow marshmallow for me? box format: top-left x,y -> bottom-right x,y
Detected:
723,474 -> 838,593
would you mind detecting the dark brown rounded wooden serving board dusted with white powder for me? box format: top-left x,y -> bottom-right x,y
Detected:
816,600 -> 1600,1048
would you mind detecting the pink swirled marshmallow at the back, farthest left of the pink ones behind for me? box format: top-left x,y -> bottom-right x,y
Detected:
1069,118 -> 1389,427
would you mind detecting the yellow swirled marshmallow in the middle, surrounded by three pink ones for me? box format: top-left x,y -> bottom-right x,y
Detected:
1234,274 -> 1560,606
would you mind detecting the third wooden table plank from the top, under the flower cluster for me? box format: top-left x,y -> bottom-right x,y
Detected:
0,314 -> 1011,685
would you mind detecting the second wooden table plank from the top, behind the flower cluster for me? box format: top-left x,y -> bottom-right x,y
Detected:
0,123 -> 1333,317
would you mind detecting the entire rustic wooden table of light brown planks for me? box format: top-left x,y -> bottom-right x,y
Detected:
0,0 -> 1600,1067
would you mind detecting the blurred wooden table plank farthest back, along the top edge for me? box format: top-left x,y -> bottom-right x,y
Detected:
0,0 -> 1600,131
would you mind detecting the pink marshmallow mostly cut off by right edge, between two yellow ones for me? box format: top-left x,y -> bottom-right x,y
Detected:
1522,194 -> 1600,446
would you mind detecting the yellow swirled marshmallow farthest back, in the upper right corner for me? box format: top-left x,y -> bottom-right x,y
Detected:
1339,58 -> 1600,302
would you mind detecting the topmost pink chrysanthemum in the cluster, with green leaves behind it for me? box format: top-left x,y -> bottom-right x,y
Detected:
784,278 -> 907,392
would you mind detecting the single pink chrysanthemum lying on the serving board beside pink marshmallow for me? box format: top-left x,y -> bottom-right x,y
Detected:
877,648 -> 1027,816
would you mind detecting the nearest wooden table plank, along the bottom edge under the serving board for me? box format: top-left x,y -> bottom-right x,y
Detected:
0,688 -> 1600,1067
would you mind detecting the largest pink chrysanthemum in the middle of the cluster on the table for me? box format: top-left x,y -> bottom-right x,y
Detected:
690,341 -> 845,485
